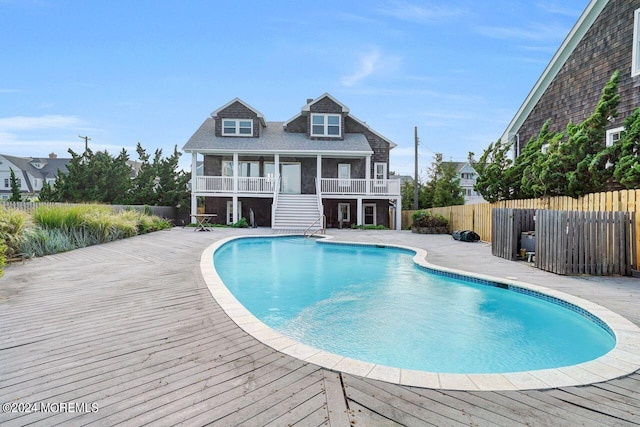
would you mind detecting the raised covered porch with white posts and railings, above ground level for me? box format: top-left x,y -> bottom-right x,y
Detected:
191,151 -> 401,229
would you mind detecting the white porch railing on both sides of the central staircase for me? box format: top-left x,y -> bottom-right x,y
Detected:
194,176 -> 400,196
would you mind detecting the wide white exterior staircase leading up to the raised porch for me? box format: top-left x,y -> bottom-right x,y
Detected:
272,193 -> 322,232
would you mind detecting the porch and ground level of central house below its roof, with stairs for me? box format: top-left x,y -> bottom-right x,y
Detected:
191,150 -> 401,230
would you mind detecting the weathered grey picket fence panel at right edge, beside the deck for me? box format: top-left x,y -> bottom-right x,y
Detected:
535,210 -> 637,276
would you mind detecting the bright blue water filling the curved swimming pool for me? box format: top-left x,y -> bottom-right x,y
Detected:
214,237 -> 615,373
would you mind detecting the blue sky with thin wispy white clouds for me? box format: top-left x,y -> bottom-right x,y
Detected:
0,0 -> 589,175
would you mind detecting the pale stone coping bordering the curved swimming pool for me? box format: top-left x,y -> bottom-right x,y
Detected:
200,234 -> 640,391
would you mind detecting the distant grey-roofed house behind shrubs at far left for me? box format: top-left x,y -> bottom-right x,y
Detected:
0,153 -> 71,200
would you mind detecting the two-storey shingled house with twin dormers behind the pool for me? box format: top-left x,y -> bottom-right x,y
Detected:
183,94 -> 401,230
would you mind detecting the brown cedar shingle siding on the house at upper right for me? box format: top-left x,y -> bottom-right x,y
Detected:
517,0 -> 640,148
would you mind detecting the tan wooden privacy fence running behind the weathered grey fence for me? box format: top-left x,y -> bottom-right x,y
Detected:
402,190 -> 640,274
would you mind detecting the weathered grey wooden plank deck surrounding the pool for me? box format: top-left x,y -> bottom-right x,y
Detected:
0,228 -> 640,426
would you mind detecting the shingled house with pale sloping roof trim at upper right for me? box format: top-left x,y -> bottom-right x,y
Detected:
502,0 -> 640,156
